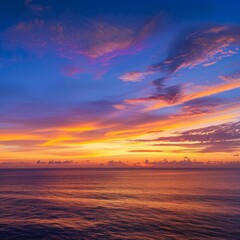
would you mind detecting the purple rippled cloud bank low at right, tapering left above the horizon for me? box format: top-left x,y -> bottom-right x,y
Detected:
137,122 -> 240,152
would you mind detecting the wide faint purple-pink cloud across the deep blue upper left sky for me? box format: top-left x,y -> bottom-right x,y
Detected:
3,14 -> 159,64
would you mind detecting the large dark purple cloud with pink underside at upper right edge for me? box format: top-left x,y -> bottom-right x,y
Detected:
149,26 -> 240,73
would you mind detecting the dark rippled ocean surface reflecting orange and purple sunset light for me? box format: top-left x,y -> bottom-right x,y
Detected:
0,169 -> 240,240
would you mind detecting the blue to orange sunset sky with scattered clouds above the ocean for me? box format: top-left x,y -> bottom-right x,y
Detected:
0,0 -> 240,168
